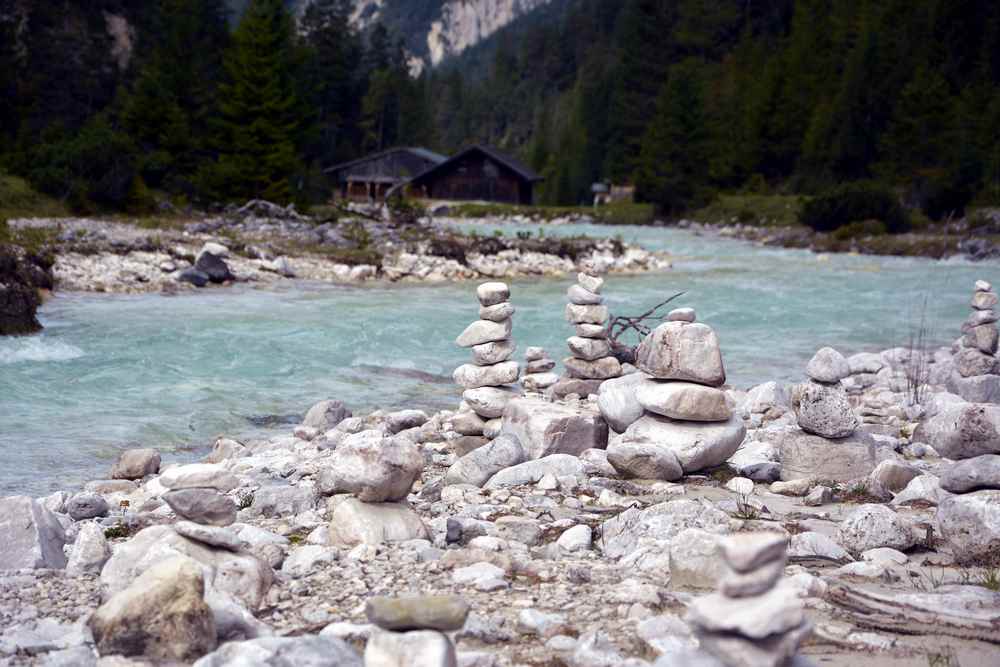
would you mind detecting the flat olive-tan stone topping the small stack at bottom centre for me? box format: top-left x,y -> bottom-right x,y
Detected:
365,595 -> 469,632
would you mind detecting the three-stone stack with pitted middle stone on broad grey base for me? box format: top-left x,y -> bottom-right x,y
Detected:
771,347 -> 877,482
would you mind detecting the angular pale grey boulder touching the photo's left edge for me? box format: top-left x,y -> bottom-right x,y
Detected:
0,496 -> 66,570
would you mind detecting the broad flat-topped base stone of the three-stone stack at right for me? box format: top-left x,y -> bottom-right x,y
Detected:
768,428 -> 878,482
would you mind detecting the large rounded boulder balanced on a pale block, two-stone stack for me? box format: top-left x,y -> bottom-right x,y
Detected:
318,429 -> 427,547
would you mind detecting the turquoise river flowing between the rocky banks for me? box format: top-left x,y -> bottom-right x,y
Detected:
0,225 -> 1000,496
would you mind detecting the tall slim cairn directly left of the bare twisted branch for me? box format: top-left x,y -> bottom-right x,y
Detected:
553,273 -> 622,398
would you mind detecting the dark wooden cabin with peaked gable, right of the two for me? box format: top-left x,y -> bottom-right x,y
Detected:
408,146 -> 542,204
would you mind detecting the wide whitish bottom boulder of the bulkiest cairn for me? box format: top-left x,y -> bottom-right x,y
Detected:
612,413 -> 746,474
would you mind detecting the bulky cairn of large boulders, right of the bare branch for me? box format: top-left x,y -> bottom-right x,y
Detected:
598,308 -> 746,481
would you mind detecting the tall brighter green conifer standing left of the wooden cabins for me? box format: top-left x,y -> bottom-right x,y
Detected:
203,0 -> 306,202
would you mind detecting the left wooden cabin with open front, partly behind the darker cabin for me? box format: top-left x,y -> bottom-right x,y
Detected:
324,147 -> 447,201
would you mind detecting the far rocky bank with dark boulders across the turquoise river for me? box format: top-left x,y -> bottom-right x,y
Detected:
10,203 -> 670,293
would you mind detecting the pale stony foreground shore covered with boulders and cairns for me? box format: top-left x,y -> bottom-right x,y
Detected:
0,274 -> 1000,667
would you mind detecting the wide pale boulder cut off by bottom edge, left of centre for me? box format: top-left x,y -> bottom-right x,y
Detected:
194,635 -> 362,667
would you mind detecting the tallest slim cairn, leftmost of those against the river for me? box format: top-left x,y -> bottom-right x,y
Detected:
452,282 -> 521,438
